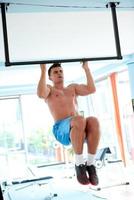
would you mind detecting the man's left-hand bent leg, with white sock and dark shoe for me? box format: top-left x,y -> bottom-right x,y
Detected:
70,116 -> 89,185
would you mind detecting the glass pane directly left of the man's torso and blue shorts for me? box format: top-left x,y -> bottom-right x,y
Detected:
22,95 -> 62,165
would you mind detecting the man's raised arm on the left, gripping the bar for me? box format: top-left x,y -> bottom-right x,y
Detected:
37,64 -> 50,99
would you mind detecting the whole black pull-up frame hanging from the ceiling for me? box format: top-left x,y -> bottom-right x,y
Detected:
0,2 -> 122,66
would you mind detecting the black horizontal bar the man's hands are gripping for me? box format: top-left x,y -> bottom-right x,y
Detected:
5,56 -> 121,66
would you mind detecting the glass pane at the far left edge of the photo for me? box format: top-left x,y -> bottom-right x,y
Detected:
0,98 -> 25,178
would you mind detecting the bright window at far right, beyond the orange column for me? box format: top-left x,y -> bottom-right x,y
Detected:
117,71 -> 134,159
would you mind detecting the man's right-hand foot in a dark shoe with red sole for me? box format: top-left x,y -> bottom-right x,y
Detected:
86,165 -> 99,185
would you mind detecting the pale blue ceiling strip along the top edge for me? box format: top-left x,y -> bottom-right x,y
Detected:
0,0 -> 134,12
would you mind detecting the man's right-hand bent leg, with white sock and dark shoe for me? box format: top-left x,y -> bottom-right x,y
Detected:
85,117 -> 100,185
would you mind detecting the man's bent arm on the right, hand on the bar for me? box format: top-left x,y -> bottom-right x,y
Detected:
75,61 -> 96,96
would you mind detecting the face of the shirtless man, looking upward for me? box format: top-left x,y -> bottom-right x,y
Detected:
49,67 -> 64,83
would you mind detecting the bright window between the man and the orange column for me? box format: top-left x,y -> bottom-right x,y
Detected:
89,78 -> 120,158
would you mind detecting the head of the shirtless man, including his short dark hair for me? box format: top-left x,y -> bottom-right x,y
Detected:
48,63 -> 63,83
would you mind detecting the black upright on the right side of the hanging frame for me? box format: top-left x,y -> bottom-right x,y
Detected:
109,2 -> 122,59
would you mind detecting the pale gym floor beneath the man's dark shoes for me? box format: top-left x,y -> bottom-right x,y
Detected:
1,162 -> 134,200
